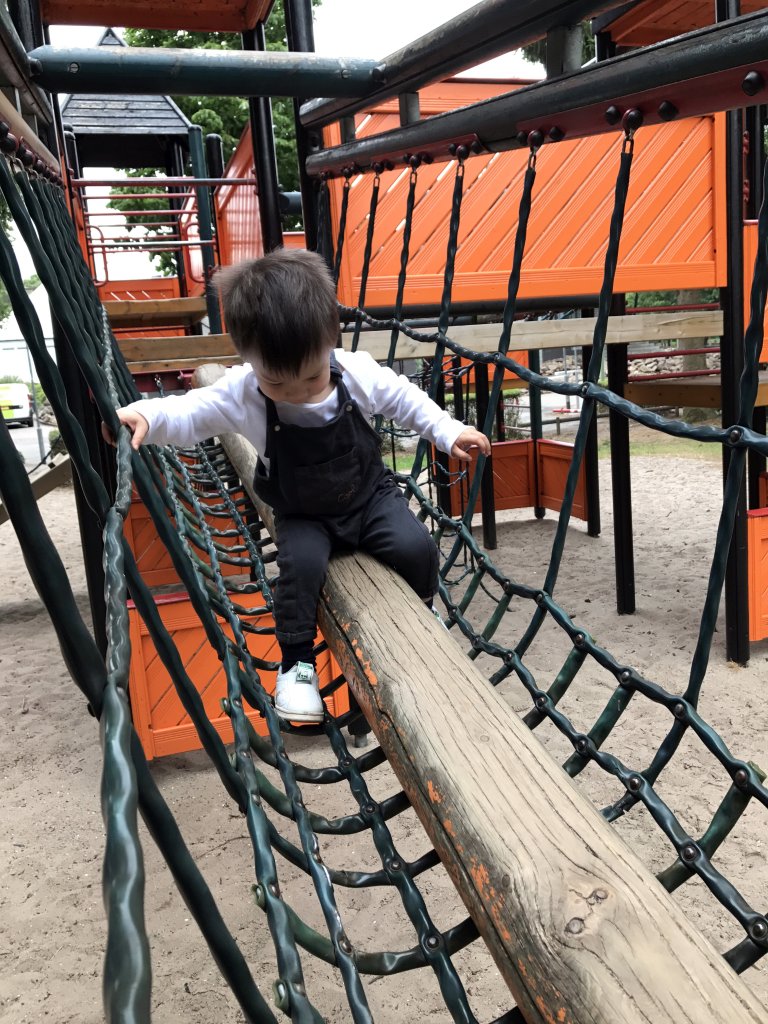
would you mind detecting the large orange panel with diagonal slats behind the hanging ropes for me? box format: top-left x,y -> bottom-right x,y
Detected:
325,80 -> 725,306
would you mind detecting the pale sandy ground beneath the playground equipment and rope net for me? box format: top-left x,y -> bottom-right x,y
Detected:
0,434 -> 768,1024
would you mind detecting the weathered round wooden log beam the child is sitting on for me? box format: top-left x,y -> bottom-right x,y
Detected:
195,367 -> 765,1024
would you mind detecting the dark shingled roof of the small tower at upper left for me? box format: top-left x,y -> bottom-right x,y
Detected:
61,29 -> 190,168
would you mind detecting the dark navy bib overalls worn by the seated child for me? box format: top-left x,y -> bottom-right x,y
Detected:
254,355 -> 437,647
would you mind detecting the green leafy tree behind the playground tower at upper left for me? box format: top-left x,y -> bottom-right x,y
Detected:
110,0 -> 322,274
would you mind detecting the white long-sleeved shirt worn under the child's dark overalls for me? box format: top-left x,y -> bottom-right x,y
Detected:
129,349 -> 466,468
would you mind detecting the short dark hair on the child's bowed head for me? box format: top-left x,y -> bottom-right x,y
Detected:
214,249 -> 339,374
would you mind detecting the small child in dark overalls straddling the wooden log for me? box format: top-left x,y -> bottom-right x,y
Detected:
111,249 -> 490,722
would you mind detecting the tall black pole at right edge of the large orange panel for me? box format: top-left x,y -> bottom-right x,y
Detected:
716,0 -> 750,665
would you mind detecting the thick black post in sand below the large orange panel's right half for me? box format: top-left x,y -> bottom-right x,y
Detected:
607,319 -> 636,615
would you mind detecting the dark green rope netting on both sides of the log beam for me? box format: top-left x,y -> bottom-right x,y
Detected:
0,121 -> 768,1022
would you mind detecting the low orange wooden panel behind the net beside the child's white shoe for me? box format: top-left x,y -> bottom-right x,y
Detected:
128,594 -> 349,760
